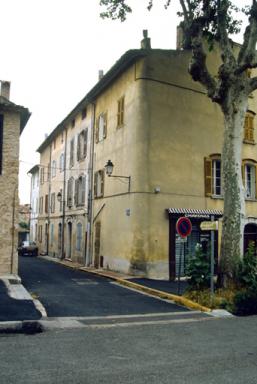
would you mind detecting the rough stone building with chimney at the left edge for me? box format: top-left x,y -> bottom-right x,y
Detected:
0,81 -> 30,275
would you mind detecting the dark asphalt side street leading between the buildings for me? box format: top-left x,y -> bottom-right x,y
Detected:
19,257 -> 187,317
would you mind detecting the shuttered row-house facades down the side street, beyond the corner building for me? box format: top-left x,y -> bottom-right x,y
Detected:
37,100 -> 93,264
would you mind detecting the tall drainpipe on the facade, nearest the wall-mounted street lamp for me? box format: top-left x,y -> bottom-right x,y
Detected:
85,103 -> 95,266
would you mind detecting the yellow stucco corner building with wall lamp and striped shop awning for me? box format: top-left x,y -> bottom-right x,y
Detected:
88,35 -> 257,279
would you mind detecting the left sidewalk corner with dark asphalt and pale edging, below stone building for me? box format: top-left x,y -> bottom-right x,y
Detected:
0,275 -> 42,333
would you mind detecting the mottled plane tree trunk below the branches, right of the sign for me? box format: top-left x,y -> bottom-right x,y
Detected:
220,95 -> 248,286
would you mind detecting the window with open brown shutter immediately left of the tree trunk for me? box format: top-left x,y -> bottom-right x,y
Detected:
204,155 -> 222,196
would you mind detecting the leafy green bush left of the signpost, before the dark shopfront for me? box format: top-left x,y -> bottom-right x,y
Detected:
186,246 -> 210,290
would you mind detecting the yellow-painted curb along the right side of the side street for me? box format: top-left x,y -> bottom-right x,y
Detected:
39,256 -> 212,313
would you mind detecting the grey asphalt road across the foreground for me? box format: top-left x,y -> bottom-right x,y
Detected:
0,317 -> 257,384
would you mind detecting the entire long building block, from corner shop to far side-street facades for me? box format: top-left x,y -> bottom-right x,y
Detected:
32,32 -> 257,279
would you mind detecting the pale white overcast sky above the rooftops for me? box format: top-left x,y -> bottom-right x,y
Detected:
0,0 -> 248,204
